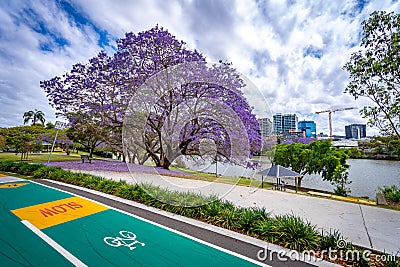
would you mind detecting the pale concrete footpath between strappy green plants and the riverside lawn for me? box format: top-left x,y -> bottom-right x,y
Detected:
76,171 -> 400,254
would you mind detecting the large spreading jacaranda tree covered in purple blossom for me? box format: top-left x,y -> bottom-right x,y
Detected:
40,26 -> 261,168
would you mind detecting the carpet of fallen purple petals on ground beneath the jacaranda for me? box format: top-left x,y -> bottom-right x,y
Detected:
49,160 -> 193,178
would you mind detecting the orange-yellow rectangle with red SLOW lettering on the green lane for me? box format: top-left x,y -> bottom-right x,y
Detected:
11,197 -> 108,229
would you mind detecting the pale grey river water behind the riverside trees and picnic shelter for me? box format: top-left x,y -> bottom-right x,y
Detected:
187,159 -> 400,199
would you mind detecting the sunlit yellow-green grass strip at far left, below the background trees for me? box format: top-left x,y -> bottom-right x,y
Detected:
0,151 -> 97,163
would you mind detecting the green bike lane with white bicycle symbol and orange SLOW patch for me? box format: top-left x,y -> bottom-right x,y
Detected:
0,177 -> 262,266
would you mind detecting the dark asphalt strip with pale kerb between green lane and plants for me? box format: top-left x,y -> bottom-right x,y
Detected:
37,180 -> 332,267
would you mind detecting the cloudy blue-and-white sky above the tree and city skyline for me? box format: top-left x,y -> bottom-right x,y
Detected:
0,0 -> 400,134
